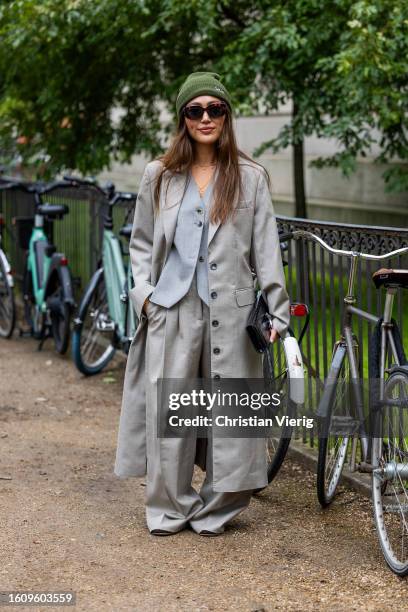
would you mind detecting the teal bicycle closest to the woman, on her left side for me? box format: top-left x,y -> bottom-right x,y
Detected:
69,176 -> 138,376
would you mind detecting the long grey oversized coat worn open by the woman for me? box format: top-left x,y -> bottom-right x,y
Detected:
114,158 -> 289,491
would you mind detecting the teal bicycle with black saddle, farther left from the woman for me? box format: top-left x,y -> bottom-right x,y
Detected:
0,180 -> 75,354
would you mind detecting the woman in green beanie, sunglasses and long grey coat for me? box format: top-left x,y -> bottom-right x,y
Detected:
115,72 -> 289,535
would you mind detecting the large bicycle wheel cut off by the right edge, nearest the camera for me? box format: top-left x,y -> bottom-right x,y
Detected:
372,368 -> 408,576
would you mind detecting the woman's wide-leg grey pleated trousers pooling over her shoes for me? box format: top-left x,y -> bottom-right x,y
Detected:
146,277 -> 252,533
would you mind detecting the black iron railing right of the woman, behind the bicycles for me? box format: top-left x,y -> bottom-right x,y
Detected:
277,216 -> 408,445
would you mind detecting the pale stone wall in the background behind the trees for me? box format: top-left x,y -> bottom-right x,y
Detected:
99,106 -> 408,228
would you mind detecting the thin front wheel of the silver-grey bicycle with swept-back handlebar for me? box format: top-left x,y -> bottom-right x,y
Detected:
316,344 -> 354,508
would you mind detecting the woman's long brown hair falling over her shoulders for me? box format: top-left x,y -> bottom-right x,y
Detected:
154,104 -> 270,223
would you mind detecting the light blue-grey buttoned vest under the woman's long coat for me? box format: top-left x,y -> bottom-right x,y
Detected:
149,174 -> 213,308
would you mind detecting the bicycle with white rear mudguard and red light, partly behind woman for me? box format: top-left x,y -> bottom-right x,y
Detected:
254,233 -> 310,493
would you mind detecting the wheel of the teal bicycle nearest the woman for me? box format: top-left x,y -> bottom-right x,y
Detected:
72,274 -> 116,376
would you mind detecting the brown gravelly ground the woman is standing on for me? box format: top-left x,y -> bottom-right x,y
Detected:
0,338 -> 408,612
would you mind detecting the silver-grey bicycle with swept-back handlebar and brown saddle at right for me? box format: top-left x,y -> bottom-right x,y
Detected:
286,230 -> 408,576
